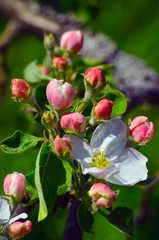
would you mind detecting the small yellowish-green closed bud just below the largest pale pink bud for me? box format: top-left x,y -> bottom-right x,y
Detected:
41,111 -> 58,129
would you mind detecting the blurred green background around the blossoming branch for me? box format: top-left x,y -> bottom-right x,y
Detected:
0,0 -> 159,240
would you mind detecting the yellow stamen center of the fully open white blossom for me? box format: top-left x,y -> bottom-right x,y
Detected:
92,152 -> 111,169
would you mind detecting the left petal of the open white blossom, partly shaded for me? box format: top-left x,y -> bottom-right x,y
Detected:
67,134 -> 92,166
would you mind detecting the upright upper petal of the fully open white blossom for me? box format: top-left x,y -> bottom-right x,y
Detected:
90,118 -> 127,161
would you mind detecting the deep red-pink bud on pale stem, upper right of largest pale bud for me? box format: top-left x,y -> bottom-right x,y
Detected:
84,67 -> 106,91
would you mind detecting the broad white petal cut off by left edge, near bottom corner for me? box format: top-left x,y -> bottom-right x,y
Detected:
0,197 -> 10,224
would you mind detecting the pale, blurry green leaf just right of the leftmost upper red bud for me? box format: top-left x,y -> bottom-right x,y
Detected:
23,61 -> 52,84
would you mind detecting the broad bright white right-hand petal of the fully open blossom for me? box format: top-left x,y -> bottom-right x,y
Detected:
107,148 -> 148,186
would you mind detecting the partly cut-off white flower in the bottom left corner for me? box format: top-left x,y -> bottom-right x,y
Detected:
0,197 -> 28,240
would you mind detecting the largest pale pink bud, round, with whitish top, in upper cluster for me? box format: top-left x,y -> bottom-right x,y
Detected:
46,79 -> 75,109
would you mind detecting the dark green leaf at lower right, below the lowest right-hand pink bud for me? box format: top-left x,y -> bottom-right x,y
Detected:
105,207 -> 133,237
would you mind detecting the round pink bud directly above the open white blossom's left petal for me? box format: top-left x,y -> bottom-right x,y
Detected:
60,112 -> 87,134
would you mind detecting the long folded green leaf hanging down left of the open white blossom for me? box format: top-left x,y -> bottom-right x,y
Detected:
35,142 -> 66,221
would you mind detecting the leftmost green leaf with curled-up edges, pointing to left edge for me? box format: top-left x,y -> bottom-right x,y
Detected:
0,130 -> 42,154
